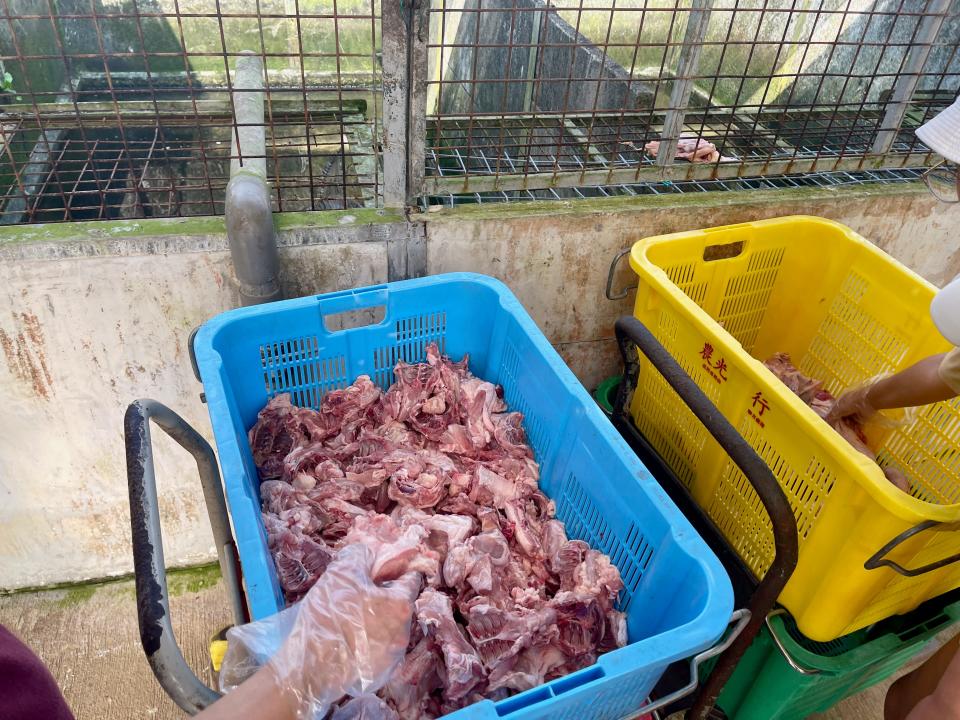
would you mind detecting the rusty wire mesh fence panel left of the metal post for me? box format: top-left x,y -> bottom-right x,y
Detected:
0,0 -> 380,224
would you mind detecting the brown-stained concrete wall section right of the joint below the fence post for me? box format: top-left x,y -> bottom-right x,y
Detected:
427,187 -> 960,388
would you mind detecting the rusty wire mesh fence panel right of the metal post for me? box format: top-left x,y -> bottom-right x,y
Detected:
426,0 -> 960,195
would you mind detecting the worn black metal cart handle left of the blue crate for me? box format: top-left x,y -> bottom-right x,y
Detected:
123,400 -> 247,715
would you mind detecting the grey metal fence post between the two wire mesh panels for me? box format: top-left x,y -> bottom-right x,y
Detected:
381,0 -> 430,208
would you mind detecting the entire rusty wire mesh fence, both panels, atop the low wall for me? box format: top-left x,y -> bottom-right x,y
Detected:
0,0 -> 960,224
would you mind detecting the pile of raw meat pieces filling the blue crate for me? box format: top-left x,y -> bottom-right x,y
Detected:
250,346 -> 626,718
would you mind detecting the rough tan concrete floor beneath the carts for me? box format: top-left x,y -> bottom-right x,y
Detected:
0,568 -> 936,720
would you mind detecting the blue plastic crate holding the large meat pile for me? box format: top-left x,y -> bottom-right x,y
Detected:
194,273 -> 733,720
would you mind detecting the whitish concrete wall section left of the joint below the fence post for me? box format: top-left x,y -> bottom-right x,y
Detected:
0,213 -> 387,588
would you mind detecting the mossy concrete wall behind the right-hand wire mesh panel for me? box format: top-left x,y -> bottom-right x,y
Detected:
430,0 -> 960,114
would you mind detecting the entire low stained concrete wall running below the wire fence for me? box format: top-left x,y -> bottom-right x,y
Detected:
0,187 -> 960,588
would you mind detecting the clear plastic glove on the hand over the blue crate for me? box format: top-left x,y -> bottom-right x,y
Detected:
221,545 -> 421,720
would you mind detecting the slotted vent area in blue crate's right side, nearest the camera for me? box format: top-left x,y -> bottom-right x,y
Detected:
557,473 -> 653,610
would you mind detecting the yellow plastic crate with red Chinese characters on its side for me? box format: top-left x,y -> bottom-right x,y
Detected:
630,216 -> 960,641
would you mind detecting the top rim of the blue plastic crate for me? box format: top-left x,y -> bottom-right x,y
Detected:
194,272 -> 733,715
